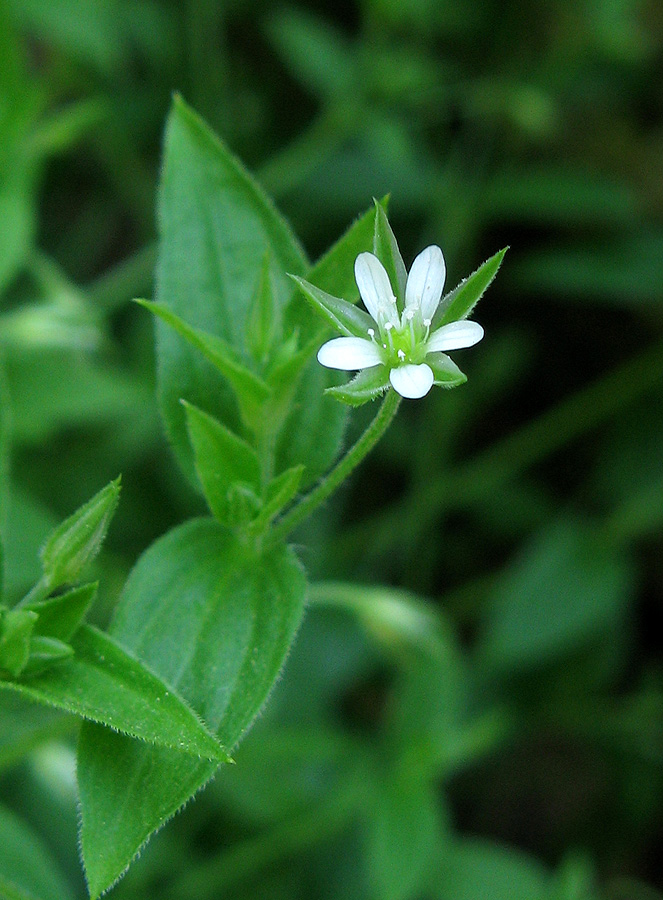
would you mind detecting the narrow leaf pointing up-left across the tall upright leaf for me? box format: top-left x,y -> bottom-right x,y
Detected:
136,300 -> 270,427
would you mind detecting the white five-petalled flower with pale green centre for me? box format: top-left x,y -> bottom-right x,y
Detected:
318,245 -> 483,398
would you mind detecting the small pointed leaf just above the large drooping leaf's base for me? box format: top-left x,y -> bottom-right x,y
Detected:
184,403 -> 260,526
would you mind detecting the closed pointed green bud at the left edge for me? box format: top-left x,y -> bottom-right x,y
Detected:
41,478 -> 120,591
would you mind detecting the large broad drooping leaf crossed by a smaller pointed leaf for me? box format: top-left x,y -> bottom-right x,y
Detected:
78,519 -> 306,897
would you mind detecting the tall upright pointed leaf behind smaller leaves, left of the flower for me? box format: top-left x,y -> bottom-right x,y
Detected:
157,99 -> 307,483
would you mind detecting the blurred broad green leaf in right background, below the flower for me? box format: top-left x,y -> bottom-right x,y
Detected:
478,519 -> 633,673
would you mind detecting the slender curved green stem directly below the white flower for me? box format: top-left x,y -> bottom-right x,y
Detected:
270,389 -> 401,541
